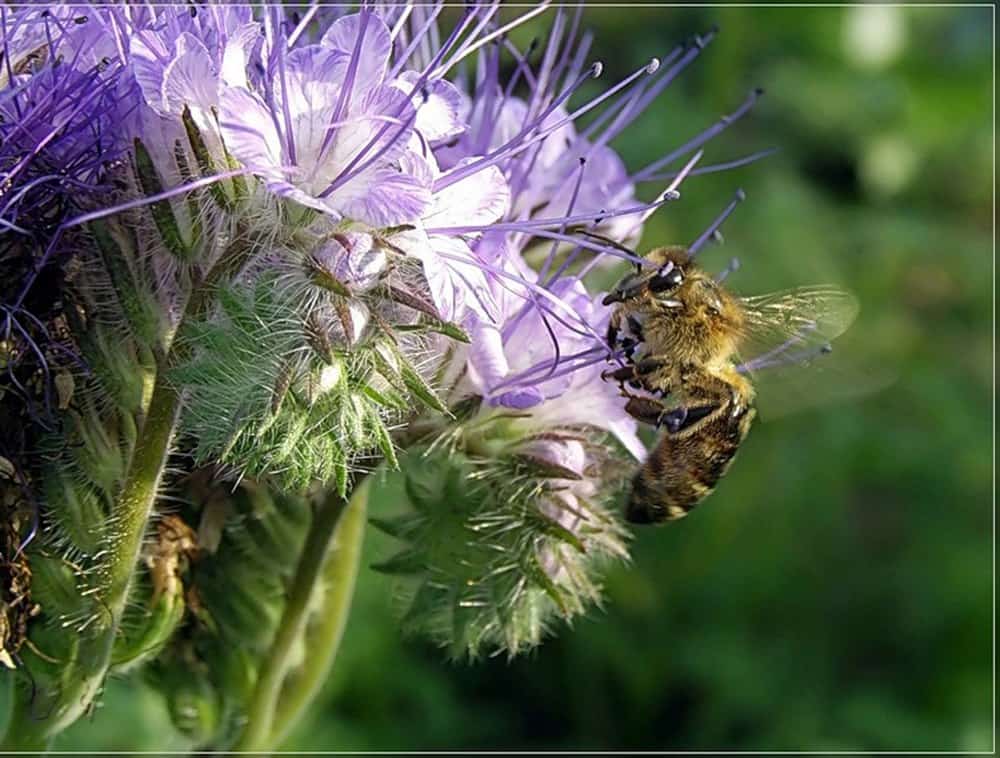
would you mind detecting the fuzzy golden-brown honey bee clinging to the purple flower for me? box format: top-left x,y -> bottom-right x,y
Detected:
604,246 -> 858,524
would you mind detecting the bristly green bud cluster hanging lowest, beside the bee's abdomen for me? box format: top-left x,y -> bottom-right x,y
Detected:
372,409 -> 626,657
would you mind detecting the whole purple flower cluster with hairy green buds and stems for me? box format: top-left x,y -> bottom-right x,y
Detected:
0,2 -> 759,749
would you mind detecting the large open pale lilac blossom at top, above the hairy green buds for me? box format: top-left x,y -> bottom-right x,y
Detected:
221,11 -> 430,227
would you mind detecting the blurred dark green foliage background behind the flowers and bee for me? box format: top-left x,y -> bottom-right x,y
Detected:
64,6 -> 993,750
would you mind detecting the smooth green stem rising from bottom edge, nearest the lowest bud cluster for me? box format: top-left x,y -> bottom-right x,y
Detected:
232,481 -> 369,751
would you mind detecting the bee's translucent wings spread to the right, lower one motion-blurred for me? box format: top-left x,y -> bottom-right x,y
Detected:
738,285 -> 892,418
